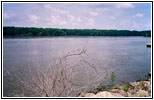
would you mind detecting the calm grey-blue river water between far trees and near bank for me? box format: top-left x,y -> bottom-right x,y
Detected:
3,37 -> 151,96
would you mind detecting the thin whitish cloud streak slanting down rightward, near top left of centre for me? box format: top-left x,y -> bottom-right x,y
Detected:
44,4 -> 70,14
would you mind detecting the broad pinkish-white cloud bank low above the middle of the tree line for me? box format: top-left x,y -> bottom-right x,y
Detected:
46,14 -> 95,28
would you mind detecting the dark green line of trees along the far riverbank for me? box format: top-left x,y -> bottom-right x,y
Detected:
3,27 -> 151,37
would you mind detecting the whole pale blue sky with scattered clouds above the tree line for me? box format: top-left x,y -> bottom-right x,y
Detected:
3,2 -> 151,31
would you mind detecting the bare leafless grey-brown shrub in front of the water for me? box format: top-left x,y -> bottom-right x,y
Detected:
6,47 -> 108,97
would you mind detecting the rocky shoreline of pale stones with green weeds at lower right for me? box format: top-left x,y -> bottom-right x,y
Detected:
79,72 -> 151,97
